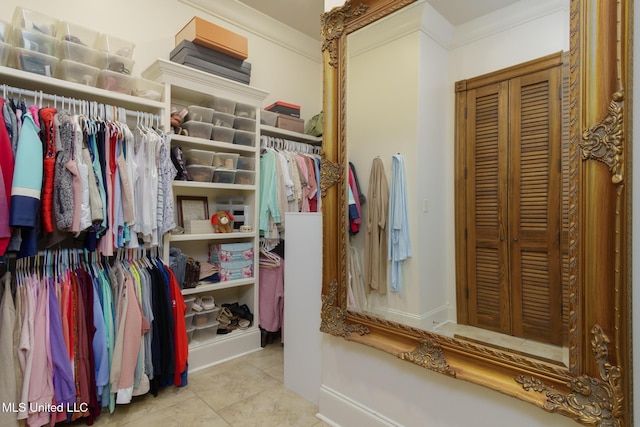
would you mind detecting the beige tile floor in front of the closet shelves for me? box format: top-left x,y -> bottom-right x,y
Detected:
90,343 -> 328,427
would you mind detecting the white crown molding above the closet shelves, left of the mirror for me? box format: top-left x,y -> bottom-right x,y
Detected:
178,0 -> 322,64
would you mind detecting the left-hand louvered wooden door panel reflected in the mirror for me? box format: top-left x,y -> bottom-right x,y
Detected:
466,82 -> 511,334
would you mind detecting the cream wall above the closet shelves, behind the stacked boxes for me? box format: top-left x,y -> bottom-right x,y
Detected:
0,0 -> 322,119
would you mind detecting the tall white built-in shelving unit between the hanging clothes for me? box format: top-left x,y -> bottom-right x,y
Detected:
142,59 -> 268,371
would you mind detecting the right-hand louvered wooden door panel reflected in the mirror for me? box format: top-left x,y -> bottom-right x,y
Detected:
509,67 -> 562,345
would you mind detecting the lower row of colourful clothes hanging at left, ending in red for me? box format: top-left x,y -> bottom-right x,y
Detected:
0,249 -> 188,425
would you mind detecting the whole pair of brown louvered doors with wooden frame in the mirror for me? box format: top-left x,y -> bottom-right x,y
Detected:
456,53 -> 568,345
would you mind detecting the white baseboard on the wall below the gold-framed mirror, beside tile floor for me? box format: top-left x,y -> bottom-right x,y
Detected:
316,385 -> 400,427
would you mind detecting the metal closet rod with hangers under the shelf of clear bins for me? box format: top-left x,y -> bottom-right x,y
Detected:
0,84 -> 160,126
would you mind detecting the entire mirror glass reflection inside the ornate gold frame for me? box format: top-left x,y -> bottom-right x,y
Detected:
345,0 -> 569,366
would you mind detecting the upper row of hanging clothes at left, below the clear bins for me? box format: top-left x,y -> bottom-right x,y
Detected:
0,85 -> 177,257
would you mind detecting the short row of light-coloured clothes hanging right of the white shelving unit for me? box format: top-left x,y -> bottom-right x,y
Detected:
259,135 -> 322,248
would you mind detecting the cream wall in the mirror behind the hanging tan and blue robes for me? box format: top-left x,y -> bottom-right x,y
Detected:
346,5 -> 422,324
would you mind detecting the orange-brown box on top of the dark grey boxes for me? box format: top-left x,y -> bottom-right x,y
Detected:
175,16 -> 249,59
